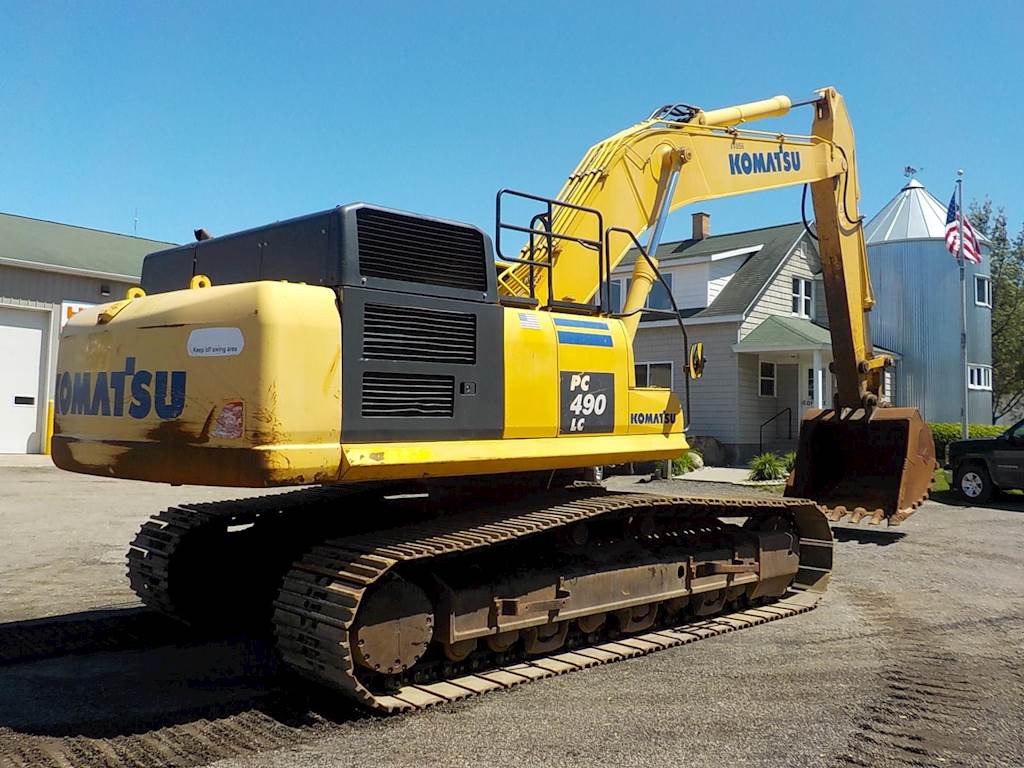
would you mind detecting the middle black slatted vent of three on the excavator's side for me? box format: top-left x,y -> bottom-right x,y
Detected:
362,304 -> 476,365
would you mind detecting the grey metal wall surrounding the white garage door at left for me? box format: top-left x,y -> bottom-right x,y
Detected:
0,264 -> 137,450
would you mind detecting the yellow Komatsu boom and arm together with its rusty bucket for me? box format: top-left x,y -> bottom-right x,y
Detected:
499,88 -> 935,522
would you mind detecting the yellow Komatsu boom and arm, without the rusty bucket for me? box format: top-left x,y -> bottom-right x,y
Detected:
500,88 -> 891,408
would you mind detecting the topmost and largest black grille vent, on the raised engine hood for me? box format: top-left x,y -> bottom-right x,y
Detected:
355,208 -> 487,292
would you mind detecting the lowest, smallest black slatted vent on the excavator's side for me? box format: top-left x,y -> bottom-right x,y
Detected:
362,372 -> 455,418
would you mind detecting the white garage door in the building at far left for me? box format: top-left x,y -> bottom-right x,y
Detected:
0,307 -> 49,454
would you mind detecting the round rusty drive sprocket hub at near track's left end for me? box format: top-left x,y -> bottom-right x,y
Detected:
351,575 -> 434,675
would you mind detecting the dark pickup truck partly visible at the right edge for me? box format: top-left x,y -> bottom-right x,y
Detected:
945,420 -> 1024,503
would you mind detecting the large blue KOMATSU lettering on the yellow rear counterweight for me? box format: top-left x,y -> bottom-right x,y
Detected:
54,357 -> 185,419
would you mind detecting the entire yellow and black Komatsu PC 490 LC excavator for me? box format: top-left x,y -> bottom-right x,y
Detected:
52,88 -> 935,712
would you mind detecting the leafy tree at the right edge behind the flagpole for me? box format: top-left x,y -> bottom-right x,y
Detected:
968,198 -> 1024,422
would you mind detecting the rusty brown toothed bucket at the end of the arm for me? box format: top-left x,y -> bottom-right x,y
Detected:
785,408 -> 936,525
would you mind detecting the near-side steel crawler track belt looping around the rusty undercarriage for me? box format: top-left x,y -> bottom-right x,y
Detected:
272,487 -> 831,713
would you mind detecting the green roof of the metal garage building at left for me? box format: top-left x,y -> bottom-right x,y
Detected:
0,213 -> 176,278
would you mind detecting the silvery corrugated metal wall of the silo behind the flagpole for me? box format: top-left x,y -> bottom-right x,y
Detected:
867,239 -> 992,424
